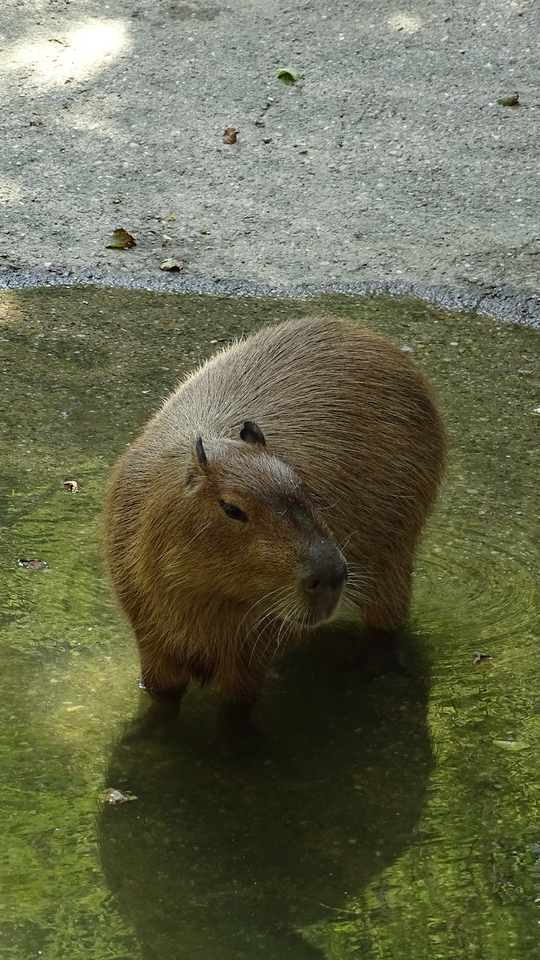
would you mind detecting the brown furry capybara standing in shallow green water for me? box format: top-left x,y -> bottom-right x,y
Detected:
105,316 -> 446,752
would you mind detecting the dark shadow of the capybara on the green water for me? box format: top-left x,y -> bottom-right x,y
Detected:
100,630 -> 432,960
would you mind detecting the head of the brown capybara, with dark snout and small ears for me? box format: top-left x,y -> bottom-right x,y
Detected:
166,422 -> 347,628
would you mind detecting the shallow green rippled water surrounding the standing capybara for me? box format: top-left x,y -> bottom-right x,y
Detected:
0,289 -> 540,960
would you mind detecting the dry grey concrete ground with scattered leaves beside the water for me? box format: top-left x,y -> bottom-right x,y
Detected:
0,0 -> 540,323
